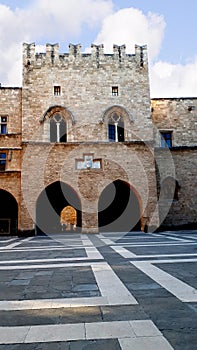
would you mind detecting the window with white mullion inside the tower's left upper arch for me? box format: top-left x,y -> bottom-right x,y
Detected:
50,113 -> 67,142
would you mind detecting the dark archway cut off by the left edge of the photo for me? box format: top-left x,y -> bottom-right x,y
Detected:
0,190 -> 18,235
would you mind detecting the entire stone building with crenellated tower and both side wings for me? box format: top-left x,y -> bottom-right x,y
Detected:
0,44 -> 197,235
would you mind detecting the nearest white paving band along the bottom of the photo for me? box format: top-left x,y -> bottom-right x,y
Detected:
0,320 -> 173,350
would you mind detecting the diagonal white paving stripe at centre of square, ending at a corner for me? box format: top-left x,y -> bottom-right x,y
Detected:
91,262 -> 138,305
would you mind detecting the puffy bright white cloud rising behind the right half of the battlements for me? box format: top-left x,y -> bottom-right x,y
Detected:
91,8 -> 165,60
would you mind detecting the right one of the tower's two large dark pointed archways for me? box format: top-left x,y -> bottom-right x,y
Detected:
98,180 -> 141,232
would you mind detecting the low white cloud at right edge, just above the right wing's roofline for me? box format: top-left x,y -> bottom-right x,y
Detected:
150,59 -> 197,97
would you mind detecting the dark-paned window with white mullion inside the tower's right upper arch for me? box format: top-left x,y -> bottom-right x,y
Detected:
108,113 -> 124,142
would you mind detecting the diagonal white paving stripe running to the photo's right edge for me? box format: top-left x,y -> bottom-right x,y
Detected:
130,261 -> 197,302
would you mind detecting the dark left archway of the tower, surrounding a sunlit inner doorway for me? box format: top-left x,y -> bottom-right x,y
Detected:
36,181 -> 81,234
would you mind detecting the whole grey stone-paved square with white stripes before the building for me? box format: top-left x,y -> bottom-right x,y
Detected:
0,231 -> 197,350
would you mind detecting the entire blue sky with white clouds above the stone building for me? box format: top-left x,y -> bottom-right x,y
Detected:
0,0 -> 197,98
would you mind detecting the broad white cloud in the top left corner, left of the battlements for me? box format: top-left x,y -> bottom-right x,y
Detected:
0,0 -> 113,86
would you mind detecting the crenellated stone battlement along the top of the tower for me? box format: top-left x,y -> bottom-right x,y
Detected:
23,43 -> 148,68
